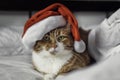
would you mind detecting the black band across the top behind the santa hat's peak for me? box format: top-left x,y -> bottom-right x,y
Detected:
0,0 -> 120,11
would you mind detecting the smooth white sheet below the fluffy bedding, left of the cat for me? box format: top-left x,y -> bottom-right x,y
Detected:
0,55 -> 42,80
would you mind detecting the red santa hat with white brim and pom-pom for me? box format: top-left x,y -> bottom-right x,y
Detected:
22,3 -> 86,53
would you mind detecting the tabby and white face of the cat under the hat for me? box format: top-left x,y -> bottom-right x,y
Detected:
34,26 -> 73,56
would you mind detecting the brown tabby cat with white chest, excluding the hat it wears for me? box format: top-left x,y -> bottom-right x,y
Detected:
32,24 -> 90,80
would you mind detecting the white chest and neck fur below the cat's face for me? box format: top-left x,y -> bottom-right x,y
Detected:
32,51 -> 73,75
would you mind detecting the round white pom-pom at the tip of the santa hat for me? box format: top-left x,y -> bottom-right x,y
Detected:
74,40 -> 86,53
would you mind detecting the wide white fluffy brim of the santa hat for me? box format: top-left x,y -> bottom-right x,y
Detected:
22,15 -> 66,49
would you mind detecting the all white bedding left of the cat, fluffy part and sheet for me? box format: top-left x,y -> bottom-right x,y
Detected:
0,26 -> 41,80
